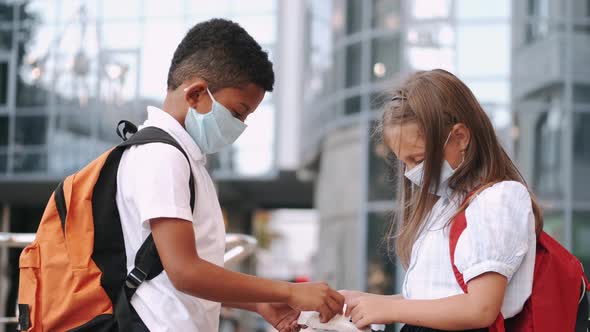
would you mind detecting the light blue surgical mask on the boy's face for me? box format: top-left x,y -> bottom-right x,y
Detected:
184,88 -> 247,154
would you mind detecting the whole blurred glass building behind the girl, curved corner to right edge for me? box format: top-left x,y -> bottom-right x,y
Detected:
302,0 -> 590,308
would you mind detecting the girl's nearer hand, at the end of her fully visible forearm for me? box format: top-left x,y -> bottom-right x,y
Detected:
345,293 -> 398,329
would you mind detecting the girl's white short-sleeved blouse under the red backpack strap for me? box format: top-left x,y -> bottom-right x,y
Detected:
402,181 -> 536,318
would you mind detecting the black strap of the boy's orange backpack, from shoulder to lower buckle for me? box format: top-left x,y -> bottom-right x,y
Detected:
114,120 -> 195,331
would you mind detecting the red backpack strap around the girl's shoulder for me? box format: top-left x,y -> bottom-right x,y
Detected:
449,183 -> 505,332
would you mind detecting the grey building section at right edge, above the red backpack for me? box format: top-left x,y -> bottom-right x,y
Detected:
512,0 -> 590,274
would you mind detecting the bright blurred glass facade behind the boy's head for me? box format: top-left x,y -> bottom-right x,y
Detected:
0,0 -> 277,183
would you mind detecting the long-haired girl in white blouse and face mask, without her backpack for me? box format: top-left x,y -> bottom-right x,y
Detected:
342,69 -> 542,331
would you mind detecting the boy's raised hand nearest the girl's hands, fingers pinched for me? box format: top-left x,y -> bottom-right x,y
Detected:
287,282 -> 344,323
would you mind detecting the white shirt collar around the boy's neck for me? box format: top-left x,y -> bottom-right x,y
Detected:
139,106 -> 205,161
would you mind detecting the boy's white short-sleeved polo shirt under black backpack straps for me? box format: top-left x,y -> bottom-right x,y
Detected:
117,107 -> 225,332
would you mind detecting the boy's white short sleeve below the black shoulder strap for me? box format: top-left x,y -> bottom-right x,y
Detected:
126,143 -> 193,228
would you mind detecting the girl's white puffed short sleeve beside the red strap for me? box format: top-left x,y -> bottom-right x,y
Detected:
455,181 -> 534,282
